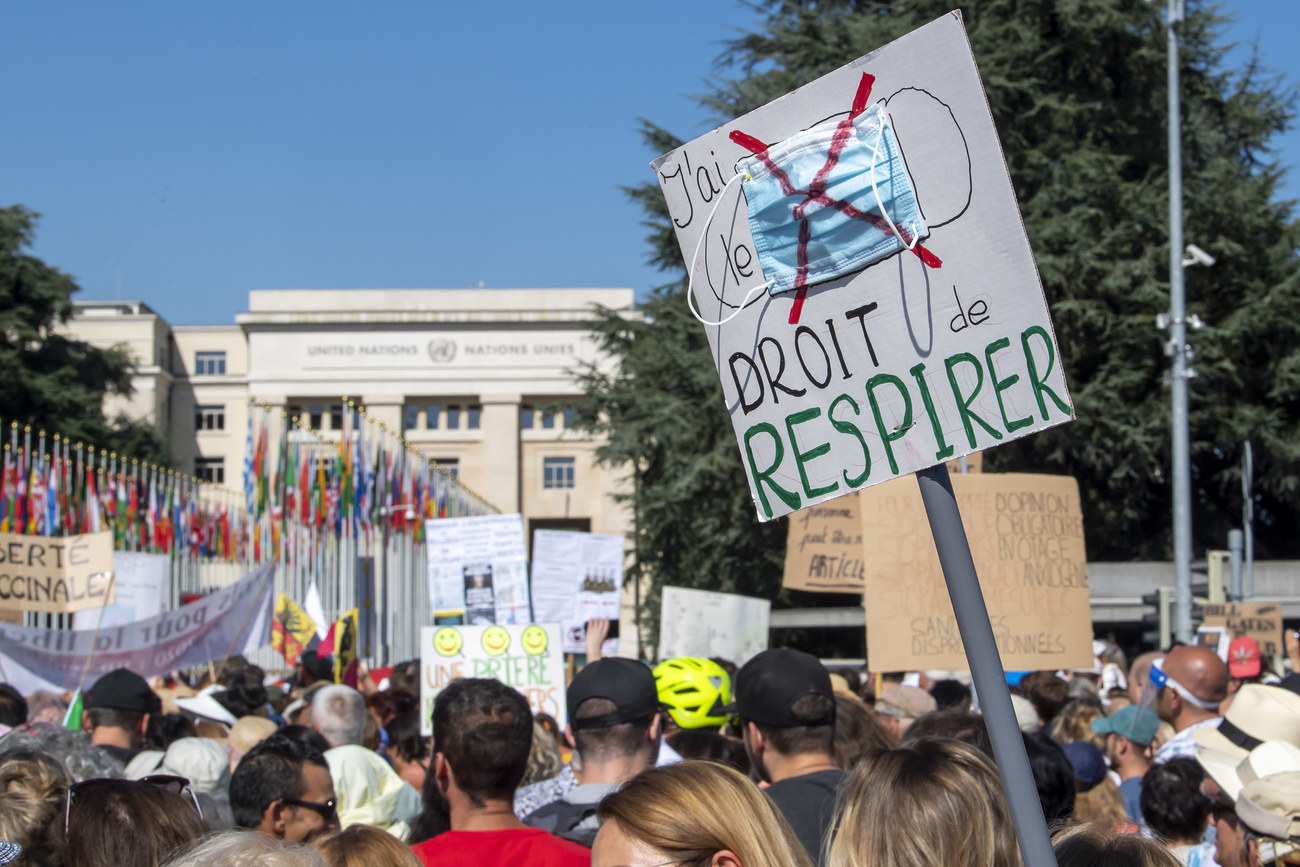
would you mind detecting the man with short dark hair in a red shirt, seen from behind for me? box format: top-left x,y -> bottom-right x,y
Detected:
412,679 -> 592,867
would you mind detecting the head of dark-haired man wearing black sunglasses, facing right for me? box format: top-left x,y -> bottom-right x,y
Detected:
230,734 -> 338,841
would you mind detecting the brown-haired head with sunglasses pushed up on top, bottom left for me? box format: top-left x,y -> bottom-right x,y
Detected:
66,780 -> 208,867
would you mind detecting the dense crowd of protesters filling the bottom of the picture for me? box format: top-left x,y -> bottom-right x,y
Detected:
0,631 -> 1300,867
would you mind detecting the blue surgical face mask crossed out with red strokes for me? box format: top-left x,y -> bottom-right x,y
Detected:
737,103 -> 940,295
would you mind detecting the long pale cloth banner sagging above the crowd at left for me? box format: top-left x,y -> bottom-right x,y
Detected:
0,563 -> 276,689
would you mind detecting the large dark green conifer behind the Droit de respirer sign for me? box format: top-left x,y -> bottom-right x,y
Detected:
586,0 -> 1300,644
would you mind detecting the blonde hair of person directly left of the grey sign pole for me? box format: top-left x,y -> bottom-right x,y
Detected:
826,738 -> 1021,867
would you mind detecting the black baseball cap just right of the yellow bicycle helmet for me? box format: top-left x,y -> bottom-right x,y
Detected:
723,647 -> 835,728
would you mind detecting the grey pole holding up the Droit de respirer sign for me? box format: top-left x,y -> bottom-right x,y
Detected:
917,464 -> 1056,867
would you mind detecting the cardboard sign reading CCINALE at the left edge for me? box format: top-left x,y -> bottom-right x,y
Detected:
0,533 -> 113,614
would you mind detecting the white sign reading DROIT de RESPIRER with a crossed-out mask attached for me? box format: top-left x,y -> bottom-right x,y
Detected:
653,13 -> 1074,521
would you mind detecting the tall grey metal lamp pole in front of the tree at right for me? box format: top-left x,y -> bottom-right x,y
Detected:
1166,0 -> 1192,643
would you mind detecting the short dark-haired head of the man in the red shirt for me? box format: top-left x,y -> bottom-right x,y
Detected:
433,677 -> 533,810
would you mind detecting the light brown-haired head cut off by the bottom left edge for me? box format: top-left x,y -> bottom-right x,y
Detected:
0,750 -> 73,864
